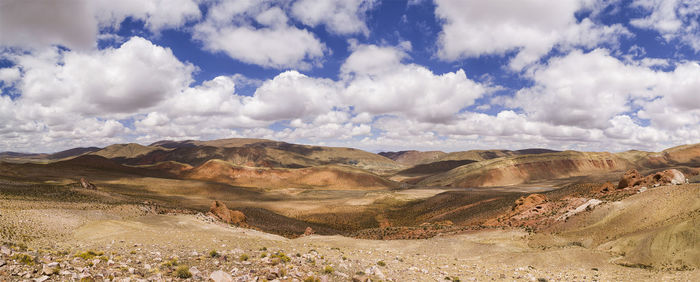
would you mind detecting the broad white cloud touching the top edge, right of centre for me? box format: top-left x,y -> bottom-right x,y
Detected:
435,0 -> 629,70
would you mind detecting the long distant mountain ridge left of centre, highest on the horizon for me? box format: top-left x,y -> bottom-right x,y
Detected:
92,138 -> 402,172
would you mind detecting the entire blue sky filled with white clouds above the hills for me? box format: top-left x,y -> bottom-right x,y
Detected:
0,0 -> 700,152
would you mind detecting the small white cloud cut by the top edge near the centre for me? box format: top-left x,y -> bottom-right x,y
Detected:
291,0 -> 374,36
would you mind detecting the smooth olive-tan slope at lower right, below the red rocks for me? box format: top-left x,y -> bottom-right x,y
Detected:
552,184 -> 700,269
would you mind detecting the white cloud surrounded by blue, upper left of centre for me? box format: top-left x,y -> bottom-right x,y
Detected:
193,1 -> 326,69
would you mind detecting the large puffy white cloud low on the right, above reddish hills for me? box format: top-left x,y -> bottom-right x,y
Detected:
507,49 -> 658,129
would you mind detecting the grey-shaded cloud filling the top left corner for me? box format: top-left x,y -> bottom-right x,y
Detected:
0,0 -> 201,50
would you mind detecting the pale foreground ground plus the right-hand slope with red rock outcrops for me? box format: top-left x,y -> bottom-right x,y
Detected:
0,169 -> 700,281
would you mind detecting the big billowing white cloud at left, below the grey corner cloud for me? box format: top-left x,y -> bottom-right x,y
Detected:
14,37 -> 194,115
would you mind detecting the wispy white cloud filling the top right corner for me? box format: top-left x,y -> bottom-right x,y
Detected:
630,0 -> 700,51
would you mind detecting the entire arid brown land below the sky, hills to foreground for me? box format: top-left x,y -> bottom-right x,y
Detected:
0,139 -> 700,281
